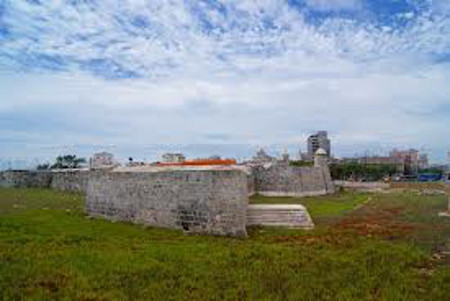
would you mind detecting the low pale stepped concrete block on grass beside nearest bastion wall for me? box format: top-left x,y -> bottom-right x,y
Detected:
247,205 -> 314,229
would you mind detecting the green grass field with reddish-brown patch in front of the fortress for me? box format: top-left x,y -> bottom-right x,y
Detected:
0,189 -> 450,300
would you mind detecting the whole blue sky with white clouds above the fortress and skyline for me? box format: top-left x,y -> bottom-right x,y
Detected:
0,0 -> 450,168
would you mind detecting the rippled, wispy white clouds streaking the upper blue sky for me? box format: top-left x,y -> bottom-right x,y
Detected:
1,0 -> 450,78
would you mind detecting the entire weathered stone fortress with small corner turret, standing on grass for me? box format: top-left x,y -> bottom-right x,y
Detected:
0,149 -> 334,236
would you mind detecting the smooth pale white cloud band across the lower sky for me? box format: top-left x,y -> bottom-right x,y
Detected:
0,56 -> 450,159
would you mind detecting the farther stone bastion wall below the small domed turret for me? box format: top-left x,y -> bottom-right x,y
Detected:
253,163 -> 334,197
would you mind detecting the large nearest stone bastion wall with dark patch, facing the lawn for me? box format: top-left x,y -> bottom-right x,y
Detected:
86,170 -> 248,236
